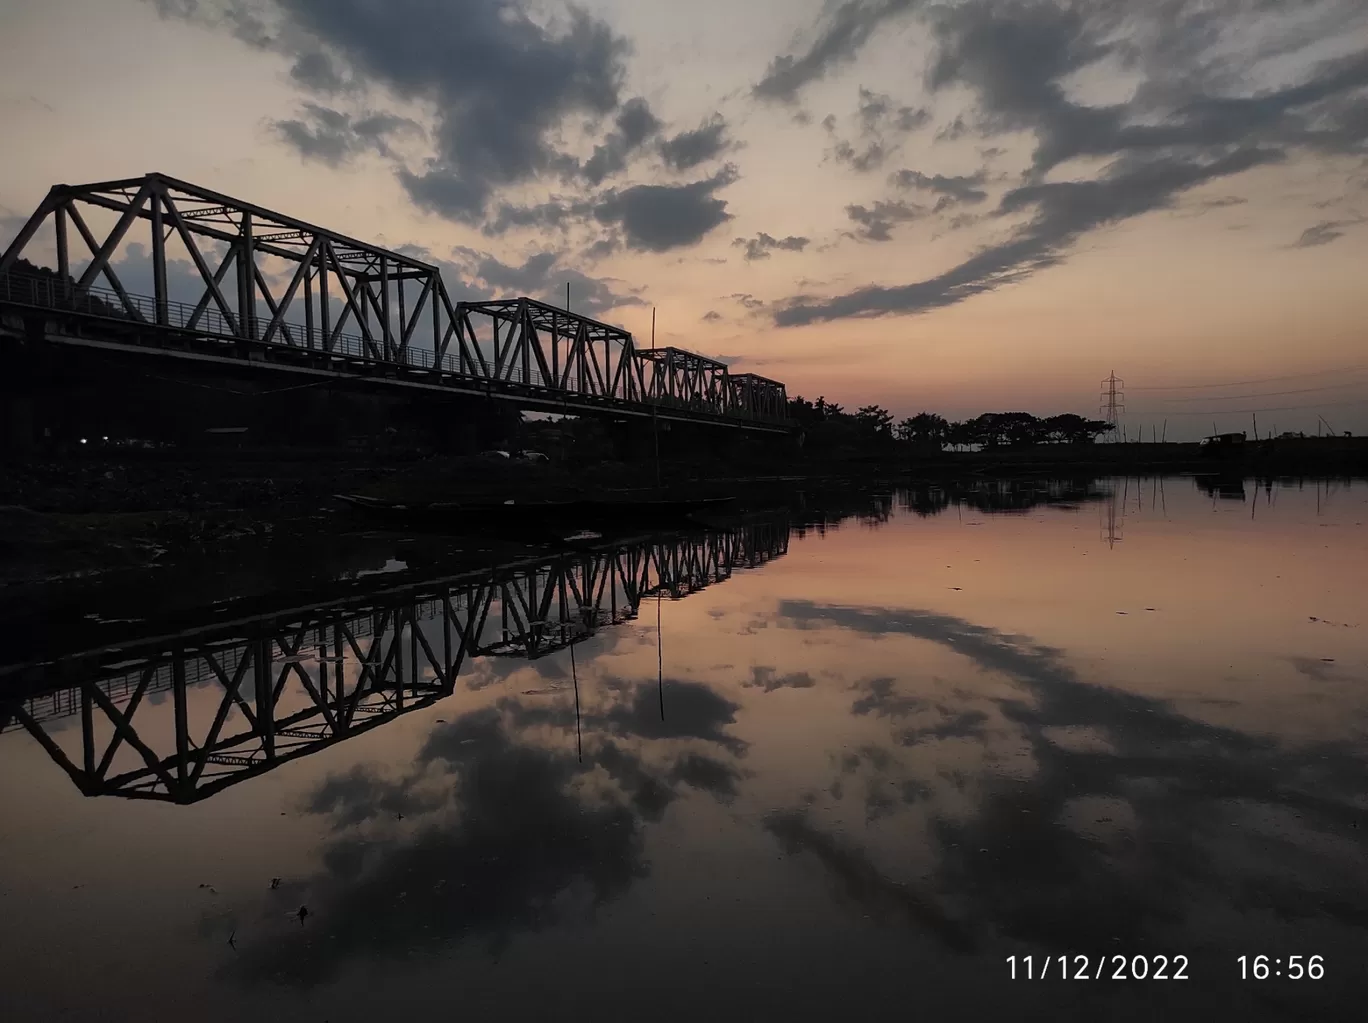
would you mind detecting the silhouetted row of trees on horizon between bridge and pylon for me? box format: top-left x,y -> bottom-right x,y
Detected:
788,395 -> 1111,451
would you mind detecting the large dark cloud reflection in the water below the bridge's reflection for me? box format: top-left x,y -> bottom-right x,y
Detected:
234,708 -> 648,986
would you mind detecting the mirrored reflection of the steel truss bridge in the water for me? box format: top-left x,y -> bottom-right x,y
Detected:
0,520 -> 788,803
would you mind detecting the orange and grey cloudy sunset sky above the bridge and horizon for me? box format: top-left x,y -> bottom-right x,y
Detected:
0,0 -> 1368,439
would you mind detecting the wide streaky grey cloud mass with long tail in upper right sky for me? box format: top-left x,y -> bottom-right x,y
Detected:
774,0 -> 1368,326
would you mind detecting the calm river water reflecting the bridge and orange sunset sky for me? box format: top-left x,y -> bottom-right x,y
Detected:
0,479 -> 1368,1023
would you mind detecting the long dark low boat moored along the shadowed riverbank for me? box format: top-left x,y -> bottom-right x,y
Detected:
334,494 -> 733,533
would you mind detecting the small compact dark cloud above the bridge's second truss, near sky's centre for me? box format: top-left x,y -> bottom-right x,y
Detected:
594,167 -> 736,252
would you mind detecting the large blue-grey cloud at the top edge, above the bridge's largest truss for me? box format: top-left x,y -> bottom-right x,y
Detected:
157,0 -> 629,223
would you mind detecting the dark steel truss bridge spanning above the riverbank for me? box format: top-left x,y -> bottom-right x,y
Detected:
0,174 -> 788,432
